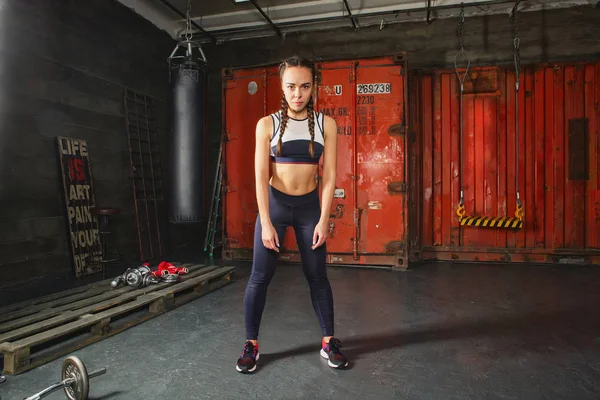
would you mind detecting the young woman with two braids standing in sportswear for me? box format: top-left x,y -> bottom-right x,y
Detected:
236,57 -> 348,373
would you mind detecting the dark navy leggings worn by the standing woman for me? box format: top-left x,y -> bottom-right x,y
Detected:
244,185 -> 333,340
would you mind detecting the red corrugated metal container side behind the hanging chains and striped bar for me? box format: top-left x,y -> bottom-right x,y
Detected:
411,63 -> 600,261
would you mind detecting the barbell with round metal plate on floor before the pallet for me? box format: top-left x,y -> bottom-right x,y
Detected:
25,356 -> 106,400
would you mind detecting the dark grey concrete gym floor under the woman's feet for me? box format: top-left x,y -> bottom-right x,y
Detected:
0,264 -> 600,400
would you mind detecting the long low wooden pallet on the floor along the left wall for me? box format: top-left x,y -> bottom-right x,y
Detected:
0,264 -> 235,375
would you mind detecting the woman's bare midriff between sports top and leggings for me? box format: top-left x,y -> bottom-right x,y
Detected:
269,163 -> 318,196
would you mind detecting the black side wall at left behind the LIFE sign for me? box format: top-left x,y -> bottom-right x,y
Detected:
0,0 -> 175,286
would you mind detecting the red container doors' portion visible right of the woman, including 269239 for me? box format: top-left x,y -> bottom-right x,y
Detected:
316,57 -> 407,266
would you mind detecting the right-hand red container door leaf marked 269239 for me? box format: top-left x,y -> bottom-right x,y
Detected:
356,65 -> 407,254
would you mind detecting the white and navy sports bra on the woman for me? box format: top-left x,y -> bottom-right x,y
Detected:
271,111 -> 325,164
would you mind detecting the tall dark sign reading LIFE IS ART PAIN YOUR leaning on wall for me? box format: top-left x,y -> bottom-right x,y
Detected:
57,136 -> 102,278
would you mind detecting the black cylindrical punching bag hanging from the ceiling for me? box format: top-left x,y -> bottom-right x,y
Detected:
168,40 -> 206,224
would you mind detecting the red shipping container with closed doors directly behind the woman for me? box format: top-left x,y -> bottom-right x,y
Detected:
223,54 -> 408,267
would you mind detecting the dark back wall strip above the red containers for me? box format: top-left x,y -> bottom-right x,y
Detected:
190,3 -> 600,256
